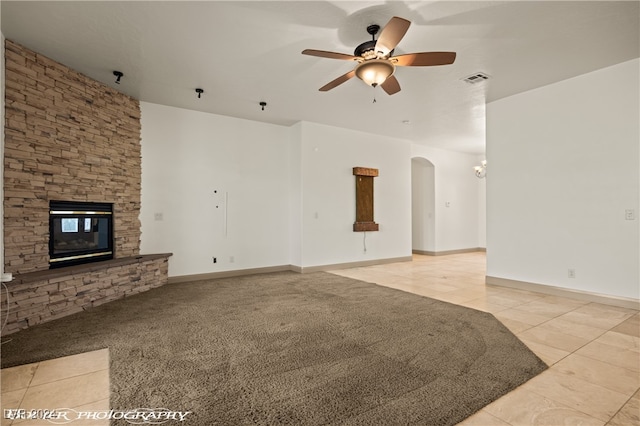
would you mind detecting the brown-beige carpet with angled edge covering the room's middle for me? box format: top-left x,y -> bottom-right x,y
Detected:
1,273 -> 546,426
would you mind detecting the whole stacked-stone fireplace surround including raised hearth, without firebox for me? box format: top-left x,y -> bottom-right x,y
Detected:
1,40 -> 170,335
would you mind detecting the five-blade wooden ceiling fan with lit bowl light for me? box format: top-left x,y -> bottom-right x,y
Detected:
302,16 -> 456,95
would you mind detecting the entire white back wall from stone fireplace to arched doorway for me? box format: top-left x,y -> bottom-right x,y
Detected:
140,102 -> 411,276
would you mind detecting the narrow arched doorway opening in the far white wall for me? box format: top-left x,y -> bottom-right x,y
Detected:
411,157 -> 436,254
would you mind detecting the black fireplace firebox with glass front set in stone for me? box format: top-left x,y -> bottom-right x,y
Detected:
49,201 -> 114,269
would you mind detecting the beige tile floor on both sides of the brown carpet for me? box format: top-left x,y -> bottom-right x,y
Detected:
1,253 -> 640,426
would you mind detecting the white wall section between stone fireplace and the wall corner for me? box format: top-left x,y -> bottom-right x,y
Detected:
140,102 -> 290,276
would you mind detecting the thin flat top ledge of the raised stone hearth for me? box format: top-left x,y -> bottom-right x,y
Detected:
5,253 -> 173,287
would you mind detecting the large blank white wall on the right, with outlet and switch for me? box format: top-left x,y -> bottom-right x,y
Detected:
487,59 -> 640,299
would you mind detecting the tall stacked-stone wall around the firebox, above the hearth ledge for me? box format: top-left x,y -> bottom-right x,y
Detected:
4,40 -> 141,274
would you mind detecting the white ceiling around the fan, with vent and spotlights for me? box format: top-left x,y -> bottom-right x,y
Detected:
1,0 -> 640,153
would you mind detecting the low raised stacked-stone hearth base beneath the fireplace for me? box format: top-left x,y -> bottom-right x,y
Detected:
0,254 -> 170,336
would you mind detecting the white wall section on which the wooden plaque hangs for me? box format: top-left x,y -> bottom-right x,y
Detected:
296,122 -> 411,267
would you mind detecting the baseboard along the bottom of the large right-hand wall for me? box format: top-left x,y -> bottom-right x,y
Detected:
485,275 -> 640,310
